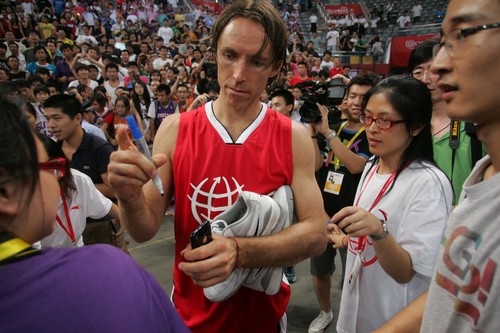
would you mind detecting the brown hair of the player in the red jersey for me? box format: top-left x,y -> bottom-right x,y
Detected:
212,0 -> 287,72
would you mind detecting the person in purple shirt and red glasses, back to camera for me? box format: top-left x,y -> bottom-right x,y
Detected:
0,97 -> 189,333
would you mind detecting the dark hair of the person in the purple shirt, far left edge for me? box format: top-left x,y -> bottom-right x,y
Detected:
0,96 -> 39,199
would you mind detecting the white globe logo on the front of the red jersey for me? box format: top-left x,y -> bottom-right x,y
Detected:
188,177 -> 245,224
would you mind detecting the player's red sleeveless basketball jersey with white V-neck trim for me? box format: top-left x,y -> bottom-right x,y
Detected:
173,103 -> 292,333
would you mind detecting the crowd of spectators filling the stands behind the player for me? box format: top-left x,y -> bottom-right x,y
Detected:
0,0 -> 390,143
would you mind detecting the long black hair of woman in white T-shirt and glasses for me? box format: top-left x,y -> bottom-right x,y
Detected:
362,75 -> 436,188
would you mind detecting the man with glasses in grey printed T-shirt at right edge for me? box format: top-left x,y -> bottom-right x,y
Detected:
377,0 -> 500,332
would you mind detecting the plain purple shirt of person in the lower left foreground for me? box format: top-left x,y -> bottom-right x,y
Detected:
0,245 -> 189,333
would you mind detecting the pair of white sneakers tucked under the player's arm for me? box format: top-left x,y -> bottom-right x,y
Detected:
203,186 -> 293,302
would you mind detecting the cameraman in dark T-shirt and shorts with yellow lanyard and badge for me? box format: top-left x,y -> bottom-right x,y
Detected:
301,73 -> 378,332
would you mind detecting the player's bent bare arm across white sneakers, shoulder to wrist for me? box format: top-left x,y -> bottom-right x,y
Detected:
238,122 -> 328,267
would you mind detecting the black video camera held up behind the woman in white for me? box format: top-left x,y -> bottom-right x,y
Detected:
299,78 -> 346,125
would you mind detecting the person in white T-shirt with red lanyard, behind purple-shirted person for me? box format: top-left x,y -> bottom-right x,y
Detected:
38,135 -> 119,248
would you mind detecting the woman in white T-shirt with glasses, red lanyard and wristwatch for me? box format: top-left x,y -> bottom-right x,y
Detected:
328,76 -> 453,332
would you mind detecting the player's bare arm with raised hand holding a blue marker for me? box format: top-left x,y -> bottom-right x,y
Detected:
108,115 -> 179,242
